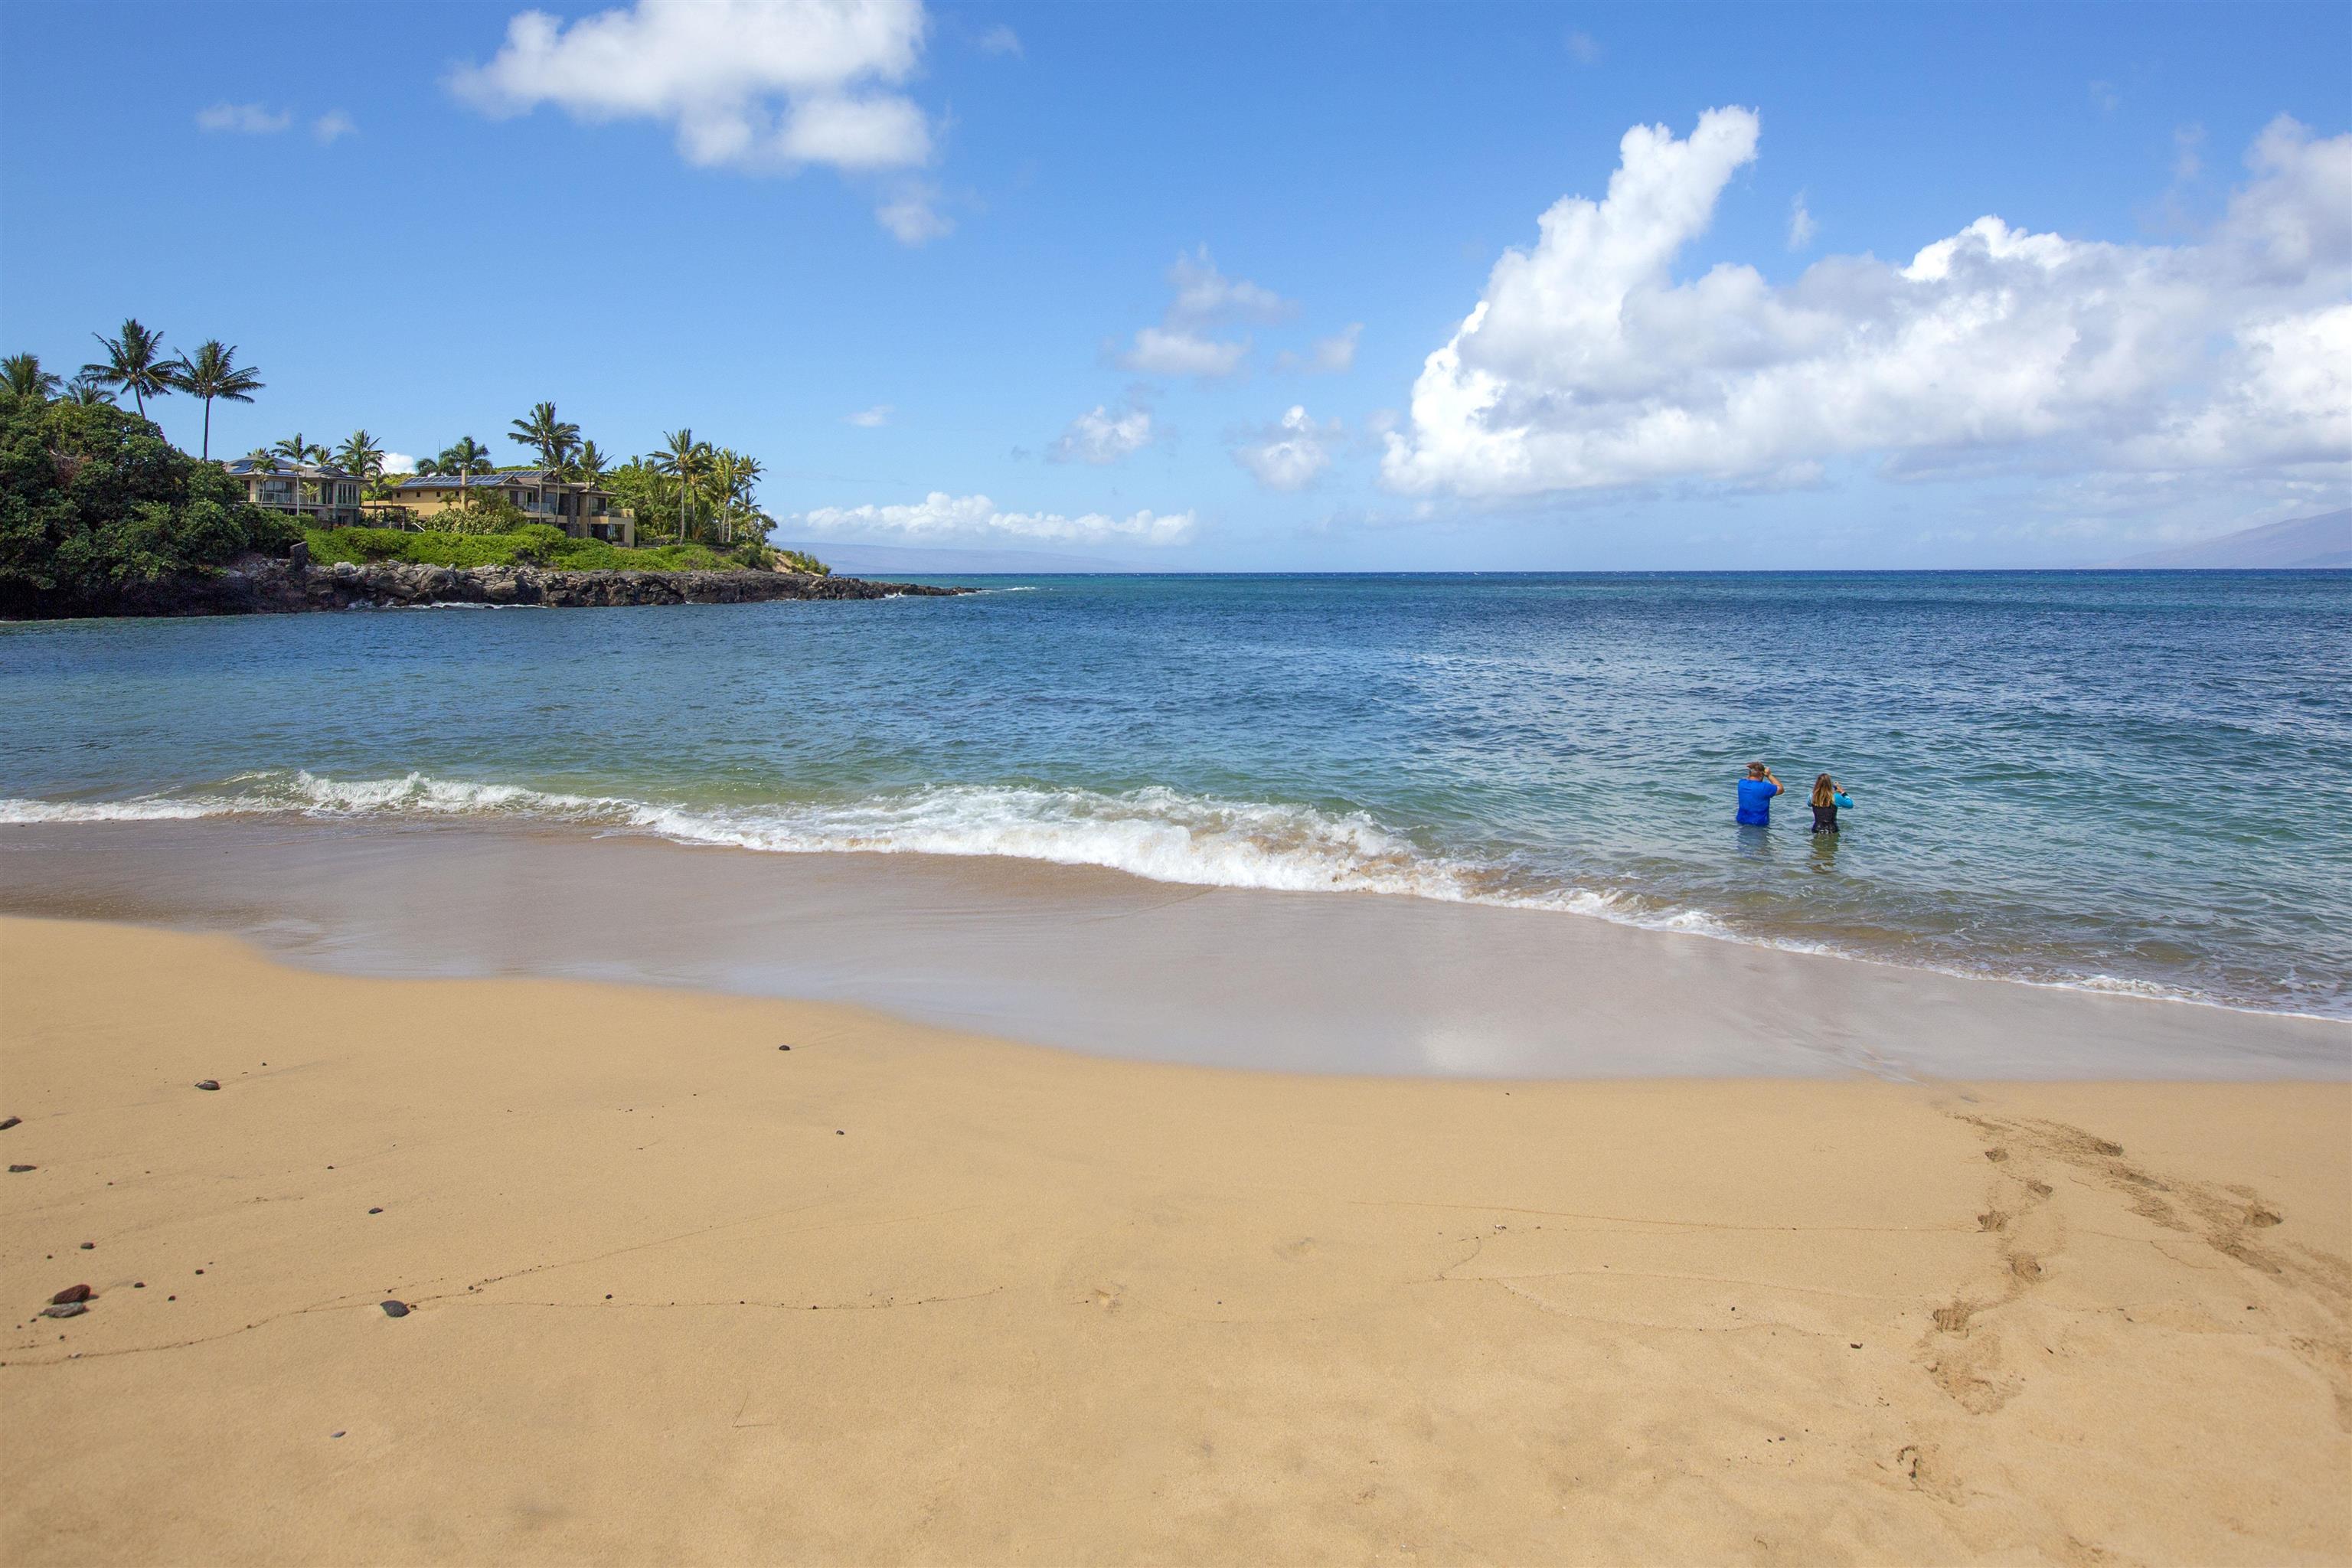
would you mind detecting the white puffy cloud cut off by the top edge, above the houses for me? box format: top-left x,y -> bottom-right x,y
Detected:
449,0 -> 936,237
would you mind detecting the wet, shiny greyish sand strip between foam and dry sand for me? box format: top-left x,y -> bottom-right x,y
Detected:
0,815 -> 2352,1081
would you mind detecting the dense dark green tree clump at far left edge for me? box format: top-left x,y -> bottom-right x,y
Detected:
0,390 -> 299,609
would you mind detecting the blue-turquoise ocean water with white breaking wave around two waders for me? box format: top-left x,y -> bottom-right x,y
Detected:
0,573 -> 2352,1015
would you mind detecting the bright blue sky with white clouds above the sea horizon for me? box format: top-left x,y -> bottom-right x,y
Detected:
0,0 -> 2352,569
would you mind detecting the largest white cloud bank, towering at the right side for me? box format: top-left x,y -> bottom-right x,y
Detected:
1380,108 -> 2352,496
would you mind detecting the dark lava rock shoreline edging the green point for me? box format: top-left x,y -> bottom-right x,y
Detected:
9,555 -> 972,621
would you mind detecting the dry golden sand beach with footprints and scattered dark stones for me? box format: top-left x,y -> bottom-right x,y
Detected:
0,920 -> 2352,1563
